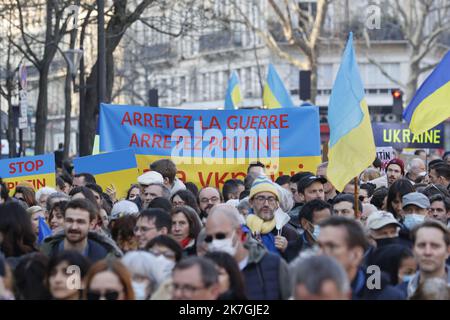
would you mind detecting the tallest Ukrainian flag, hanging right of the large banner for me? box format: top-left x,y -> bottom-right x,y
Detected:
327,32 -> 376,191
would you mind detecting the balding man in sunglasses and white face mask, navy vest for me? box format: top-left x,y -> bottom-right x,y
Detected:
204,204 -> 291,300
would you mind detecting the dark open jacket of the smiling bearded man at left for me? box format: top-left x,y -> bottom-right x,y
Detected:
41,231 -> 123,263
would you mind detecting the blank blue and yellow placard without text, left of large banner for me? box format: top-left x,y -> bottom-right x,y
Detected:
73,149 -> 138,199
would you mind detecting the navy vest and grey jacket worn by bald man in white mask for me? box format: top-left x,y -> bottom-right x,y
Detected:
242,237 -> 291,300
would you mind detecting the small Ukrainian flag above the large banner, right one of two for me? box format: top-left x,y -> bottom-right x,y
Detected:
263,63 -> 294,109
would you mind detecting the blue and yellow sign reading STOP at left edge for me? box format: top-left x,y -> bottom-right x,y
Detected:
0,153 -> 56,195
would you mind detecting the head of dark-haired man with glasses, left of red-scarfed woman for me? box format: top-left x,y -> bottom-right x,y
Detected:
134,208 -> 172,249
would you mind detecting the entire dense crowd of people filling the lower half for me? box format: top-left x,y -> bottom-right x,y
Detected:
0,154 -> 450,300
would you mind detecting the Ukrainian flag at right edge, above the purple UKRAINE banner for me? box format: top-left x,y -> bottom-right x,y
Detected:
403,51 -> 450,134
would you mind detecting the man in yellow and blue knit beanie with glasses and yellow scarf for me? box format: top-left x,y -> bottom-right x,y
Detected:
246,176 -> 298,256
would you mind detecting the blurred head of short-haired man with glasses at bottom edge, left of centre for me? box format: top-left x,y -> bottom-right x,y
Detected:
172,257 -> 220,300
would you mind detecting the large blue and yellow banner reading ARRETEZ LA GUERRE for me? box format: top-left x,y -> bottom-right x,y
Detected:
100,104 -> 321,187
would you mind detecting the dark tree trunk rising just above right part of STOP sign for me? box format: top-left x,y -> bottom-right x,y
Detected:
34,63 -> 50,154
